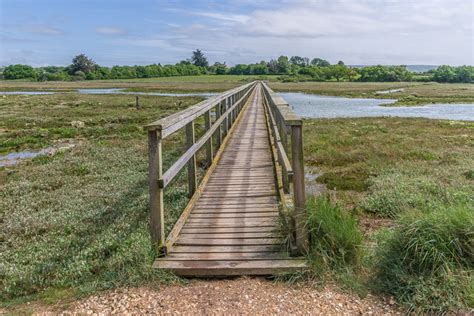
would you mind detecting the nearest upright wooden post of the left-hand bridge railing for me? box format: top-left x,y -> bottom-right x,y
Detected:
148,130 -> 165,252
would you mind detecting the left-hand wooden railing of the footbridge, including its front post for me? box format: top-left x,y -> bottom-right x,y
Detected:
146,82 -> 256,254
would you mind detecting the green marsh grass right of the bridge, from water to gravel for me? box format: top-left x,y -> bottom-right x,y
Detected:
304,118 -> 474,313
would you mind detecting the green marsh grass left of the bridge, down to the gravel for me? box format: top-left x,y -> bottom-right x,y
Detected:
0,94 -> 211,305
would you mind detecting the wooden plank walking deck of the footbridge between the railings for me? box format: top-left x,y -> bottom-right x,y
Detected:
154,87 -> 305,276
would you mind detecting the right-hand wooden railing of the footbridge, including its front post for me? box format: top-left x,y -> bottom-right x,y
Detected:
262,83 -> 308,254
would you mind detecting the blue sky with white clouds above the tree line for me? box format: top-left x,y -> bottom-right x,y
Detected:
0,0 -> 474,66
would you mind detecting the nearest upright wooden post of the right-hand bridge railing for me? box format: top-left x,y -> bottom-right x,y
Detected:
291,125 -> 308,254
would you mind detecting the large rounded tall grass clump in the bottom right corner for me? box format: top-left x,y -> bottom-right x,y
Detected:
375,205 -> 474,313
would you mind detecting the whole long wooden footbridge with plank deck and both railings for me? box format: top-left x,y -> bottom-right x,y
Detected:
147,82 -> 307,276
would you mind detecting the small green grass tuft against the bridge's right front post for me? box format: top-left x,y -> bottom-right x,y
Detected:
307,196 -> 363,269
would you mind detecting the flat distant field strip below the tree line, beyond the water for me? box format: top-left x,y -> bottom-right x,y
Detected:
0,75 -> 474,105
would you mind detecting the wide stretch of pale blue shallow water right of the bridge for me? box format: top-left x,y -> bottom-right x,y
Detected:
280,93 -> 474,121
